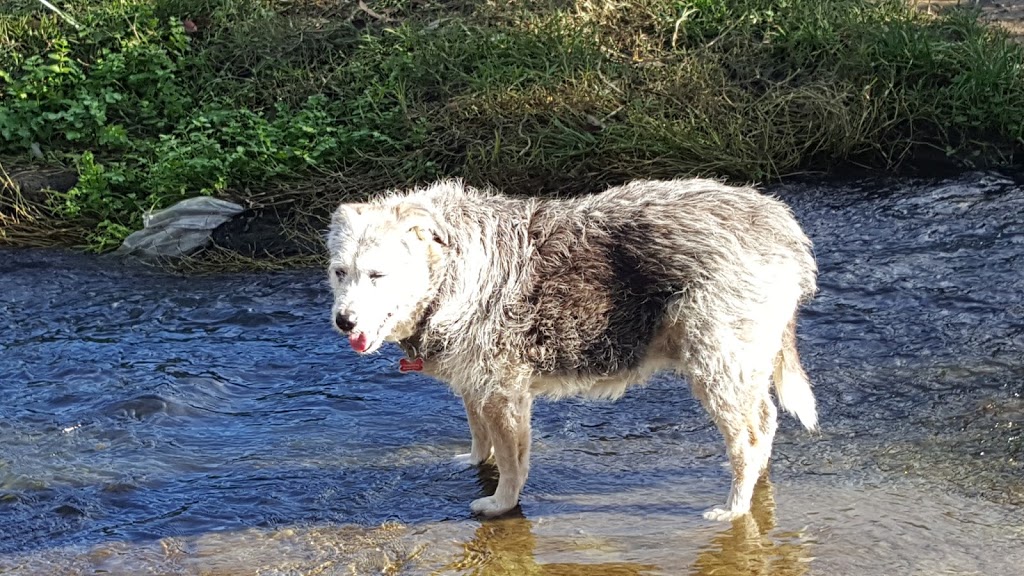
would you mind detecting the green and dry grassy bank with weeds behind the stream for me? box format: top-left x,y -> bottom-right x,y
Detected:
0,0 -> 1024,251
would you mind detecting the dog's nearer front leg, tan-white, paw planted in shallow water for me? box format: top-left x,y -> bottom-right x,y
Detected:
470,393 -> 534,516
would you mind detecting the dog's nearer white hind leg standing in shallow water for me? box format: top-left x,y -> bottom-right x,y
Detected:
692,362 -> 777,521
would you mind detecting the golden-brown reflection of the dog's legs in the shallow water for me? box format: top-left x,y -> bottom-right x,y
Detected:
438,478 -> 810,576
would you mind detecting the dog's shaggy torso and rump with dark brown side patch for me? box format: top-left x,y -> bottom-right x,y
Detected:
448,180 -> 815,377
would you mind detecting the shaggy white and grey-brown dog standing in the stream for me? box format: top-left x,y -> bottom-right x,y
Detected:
327,178 -> 817,521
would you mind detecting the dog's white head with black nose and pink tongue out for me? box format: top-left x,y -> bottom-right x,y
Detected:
328,199 -> 449,354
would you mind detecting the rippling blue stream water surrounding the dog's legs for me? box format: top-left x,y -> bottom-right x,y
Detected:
0,170 -> 1024,576
